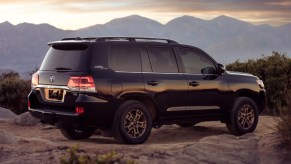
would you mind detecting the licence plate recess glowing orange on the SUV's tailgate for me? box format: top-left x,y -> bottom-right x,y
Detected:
44,88 -> 66,102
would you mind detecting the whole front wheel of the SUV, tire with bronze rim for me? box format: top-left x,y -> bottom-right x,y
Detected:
226,97 -> 259,136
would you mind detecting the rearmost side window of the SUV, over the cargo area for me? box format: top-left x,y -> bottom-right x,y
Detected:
109,46 -> 141,72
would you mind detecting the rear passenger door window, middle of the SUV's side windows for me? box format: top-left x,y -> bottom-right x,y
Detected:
147,47 -> 178,73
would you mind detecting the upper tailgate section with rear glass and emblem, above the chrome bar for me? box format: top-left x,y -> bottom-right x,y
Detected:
39,43 -> 90,86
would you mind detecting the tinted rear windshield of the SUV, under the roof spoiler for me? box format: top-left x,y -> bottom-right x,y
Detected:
40,44 -> 89,71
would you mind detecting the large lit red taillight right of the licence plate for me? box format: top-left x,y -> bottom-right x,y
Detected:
68,76 -> 96,92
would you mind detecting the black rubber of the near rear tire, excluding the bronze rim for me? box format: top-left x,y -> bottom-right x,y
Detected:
115,100 -> 152,144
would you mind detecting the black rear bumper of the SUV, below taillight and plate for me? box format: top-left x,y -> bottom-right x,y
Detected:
28,90 -> 119,129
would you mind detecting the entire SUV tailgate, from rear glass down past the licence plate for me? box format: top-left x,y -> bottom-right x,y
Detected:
37,42 -> 90,107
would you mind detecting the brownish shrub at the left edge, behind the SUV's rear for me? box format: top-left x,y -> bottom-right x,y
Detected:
0,72 -> 30,114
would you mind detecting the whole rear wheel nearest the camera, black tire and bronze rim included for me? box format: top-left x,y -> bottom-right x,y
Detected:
114,100 -> 152,144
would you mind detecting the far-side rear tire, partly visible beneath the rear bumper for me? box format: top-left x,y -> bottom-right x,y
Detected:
60,127 -> 95,140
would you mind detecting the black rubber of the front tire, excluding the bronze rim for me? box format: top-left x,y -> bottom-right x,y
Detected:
231,97 -> 259,135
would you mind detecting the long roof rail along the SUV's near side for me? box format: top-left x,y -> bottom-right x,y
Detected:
96,37 -> 178,43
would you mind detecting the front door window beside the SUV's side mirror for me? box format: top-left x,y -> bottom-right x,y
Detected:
179,48 -> 216,74
